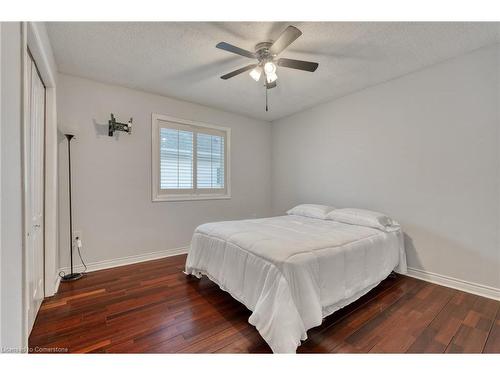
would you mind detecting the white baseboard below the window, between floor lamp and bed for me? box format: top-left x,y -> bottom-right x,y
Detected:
58,247 -> 188,279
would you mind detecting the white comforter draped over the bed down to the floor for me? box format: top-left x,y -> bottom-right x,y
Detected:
186,215 -> 406,353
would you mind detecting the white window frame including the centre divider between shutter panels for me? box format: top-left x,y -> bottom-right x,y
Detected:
151,113 -> 231,202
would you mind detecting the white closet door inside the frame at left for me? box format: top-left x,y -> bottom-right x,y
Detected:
25,54 -> 45,333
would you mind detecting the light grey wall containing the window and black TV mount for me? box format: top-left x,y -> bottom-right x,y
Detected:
57,75 -> 271,267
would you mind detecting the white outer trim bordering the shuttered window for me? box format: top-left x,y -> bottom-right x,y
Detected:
151,113 -> 231,202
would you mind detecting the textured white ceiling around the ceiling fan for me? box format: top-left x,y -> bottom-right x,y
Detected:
47,22 -> 500,120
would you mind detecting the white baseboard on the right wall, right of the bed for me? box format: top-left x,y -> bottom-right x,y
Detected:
407,267 -> 500,301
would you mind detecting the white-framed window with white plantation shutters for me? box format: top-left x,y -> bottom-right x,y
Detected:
152,114 -> 230,201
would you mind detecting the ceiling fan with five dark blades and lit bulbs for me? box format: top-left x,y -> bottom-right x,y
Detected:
216,26 -> 319,111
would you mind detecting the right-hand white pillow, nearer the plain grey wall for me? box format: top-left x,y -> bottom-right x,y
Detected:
326,208 -> 399,230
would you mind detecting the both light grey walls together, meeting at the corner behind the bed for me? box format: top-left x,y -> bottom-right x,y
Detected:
58,45 -> 500,296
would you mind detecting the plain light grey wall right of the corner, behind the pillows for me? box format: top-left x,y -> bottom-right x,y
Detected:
272,45 -> 500,288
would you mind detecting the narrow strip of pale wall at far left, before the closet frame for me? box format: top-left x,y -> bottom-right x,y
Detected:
0,22 -> 24,351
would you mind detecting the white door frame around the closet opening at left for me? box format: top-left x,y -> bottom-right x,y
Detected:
21,22 -> 59,347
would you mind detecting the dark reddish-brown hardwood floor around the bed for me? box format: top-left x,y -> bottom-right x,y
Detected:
29,255 -> 500,353
